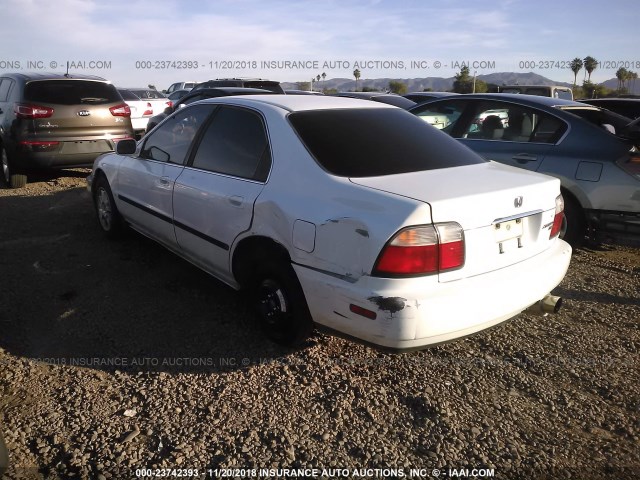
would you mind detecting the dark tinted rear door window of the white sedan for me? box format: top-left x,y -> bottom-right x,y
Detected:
193,107 -> 271,181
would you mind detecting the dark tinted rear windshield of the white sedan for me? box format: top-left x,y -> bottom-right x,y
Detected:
289,108 -> 486,177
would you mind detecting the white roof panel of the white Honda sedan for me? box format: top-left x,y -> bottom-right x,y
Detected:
198,95 -> 398,112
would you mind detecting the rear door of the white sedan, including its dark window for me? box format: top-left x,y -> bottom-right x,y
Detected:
173,105 -> 271,280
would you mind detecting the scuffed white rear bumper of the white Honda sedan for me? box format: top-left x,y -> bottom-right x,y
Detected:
294,239 -> 571,351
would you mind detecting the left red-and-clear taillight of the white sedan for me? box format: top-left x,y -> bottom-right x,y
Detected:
373,222 -> 465,277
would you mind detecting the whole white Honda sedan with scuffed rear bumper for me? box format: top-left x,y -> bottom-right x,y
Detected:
88,95 -> 571,351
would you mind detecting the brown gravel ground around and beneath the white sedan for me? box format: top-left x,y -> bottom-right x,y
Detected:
0,170 -> 640,479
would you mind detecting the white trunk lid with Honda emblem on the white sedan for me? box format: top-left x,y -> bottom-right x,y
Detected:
351,162 -> 560,281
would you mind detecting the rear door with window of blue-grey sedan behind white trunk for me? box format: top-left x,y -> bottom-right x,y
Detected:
453,100 -> 567,171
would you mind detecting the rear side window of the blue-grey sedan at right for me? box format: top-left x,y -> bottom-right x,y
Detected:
462,101 -> 566,143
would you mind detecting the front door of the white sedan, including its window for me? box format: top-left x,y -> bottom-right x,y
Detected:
117,105 -> 214,248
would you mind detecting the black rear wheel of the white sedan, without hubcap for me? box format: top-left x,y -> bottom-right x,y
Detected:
253,260 -> 313,346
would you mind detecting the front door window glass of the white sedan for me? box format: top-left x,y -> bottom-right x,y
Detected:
140,105 -> 213,164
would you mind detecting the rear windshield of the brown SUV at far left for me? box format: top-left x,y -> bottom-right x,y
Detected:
24,80 -> 122,105
